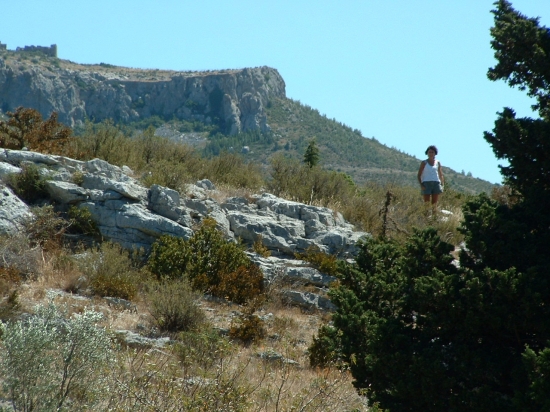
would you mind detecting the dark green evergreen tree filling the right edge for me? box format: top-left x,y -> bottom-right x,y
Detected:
317,0 -> 550,412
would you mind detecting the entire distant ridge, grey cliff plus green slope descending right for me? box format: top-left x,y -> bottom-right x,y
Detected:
0,47 -> 495,193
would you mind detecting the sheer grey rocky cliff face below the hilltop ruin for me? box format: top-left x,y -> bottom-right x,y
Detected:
0,51 -> 285,134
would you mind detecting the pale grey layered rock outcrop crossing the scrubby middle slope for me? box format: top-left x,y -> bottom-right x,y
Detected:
0,149 -> 368,309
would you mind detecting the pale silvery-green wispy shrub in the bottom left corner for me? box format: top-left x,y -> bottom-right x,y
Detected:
0,302 -> 113,411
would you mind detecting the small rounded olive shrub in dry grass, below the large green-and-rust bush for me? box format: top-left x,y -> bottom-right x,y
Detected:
147,279 -> 206,332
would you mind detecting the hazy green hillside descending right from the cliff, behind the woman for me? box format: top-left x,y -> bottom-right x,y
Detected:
221,98 -> 495,194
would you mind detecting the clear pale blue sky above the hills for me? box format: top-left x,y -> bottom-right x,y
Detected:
0,0 -> 550,183
